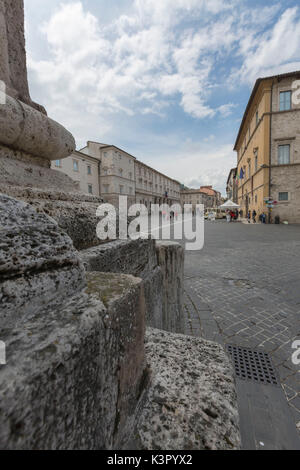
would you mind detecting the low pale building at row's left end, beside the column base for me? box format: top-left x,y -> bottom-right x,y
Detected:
51,151 -> 100,196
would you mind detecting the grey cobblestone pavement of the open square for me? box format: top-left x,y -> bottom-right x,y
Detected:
185,221 -> 300,444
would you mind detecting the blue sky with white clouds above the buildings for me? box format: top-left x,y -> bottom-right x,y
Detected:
25,0 -> 300,193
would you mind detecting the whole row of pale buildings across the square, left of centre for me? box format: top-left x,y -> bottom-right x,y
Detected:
53,141 -> 181,210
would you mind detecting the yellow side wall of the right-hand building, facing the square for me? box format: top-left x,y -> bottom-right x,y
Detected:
234,79 -> 272,217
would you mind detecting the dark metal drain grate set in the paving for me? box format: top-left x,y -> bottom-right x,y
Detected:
226,344 -> 279,385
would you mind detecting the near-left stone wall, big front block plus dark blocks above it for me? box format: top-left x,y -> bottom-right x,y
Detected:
0,195 -> 148,449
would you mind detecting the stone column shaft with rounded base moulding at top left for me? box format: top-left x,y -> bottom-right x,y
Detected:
0,0 -> 76,160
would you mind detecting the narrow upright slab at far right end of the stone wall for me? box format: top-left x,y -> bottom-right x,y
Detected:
153,241 -> 184,333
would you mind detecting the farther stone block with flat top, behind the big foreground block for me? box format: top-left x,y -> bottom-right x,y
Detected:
80,240 -> 184,333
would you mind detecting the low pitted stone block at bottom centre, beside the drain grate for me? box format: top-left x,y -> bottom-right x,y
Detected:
131,329 -> 240,450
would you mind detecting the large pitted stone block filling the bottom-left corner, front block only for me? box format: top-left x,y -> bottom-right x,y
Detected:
0,273 -> 147,449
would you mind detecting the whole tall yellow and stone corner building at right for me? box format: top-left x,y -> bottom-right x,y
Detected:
234,72 -> 300,223
